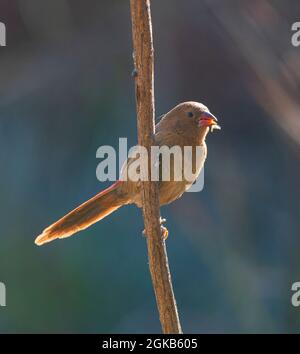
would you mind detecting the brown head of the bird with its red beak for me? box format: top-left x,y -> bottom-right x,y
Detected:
162,101 -> 221,141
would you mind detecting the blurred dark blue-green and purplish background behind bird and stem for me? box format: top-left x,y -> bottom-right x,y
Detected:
0,0 -> 300,333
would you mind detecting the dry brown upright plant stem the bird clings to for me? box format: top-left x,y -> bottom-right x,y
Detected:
130,0 -> 182,334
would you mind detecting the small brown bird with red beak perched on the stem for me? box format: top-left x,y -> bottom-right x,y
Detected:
35,101 -> 221,246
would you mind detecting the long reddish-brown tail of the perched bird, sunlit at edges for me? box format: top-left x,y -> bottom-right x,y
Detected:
35,182 -> 129,246
